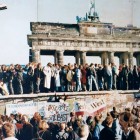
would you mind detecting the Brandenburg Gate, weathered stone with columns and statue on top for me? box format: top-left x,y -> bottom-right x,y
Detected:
27,2 -> 140,66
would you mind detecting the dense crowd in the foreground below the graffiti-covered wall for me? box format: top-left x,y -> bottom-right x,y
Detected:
0,107 -> 140,140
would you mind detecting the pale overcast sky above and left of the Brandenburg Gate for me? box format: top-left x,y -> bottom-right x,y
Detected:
0,0 -> 140,64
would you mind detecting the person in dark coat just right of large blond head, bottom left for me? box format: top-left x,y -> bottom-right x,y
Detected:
19,115 -> 33,140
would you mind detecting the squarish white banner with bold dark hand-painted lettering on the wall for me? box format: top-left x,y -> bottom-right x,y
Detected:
46,102 -> 70,122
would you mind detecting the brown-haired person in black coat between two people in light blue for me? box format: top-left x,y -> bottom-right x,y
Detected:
99,116 -> 115,140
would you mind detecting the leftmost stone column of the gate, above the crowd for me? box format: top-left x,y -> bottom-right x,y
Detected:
32,50 -> 41,63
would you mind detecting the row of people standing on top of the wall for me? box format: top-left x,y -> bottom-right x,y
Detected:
0,62 -> 140,95
